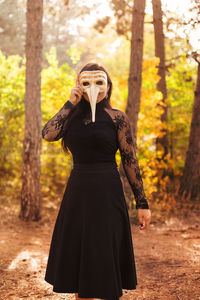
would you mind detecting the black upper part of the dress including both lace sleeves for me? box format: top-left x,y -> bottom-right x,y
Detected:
42,97 -> 149,209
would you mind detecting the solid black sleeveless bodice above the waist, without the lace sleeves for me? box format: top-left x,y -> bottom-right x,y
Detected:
64,98 -> 119,163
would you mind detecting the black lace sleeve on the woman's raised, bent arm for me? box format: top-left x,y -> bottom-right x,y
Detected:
42,100 -> 75,142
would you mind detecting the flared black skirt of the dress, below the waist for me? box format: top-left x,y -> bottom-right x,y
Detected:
45,162 -> 137,300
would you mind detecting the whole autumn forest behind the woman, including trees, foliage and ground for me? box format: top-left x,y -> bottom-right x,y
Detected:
0,0 -> 200,300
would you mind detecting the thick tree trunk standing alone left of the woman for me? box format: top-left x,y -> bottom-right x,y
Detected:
19,0 -> 43,221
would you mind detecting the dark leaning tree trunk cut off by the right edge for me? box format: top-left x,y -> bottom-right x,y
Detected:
178,59 -> 200,200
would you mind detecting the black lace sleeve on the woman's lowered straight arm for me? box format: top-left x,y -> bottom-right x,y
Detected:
115,111 -> 149,209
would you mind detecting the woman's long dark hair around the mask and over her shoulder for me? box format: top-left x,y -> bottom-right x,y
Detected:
61,62 -> 113,153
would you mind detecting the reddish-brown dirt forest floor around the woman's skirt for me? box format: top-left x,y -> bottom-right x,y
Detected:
0,206 -> 200,300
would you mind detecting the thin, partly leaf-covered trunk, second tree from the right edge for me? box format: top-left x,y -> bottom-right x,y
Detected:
152,0 -> 169,180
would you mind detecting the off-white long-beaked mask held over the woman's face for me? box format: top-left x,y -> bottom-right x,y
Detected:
80,70 -> 108,122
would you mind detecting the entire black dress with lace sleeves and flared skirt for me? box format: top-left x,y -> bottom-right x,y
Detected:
42,97 -> 148,300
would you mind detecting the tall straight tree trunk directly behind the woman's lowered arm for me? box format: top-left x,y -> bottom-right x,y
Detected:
120,0 -> 145,203
